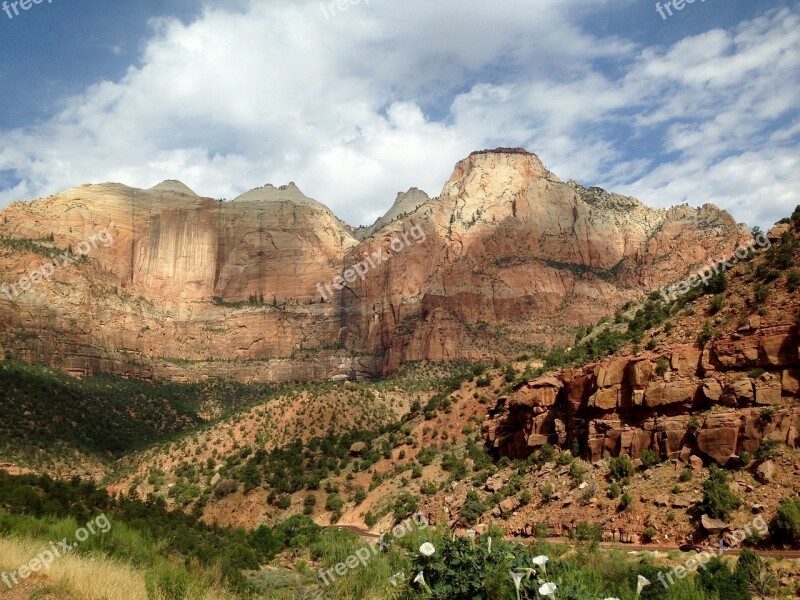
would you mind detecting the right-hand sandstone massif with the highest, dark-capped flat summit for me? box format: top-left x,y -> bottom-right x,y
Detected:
342,151 -> 746,370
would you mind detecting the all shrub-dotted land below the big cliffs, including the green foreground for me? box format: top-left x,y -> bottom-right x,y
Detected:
0,207 -> 800,600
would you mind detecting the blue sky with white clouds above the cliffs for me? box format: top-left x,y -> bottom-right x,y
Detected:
0,0 -> 800,228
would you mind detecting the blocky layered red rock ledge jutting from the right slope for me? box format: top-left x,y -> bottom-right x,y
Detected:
484,325 -> 800,465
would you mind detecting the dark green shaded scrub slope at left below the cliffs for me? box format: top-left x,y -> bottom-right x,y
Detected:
0,360 -> 279,460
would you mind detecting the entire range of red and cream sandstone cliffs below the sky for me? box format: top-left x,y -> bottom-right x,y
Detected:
0,151 -> 744,380
